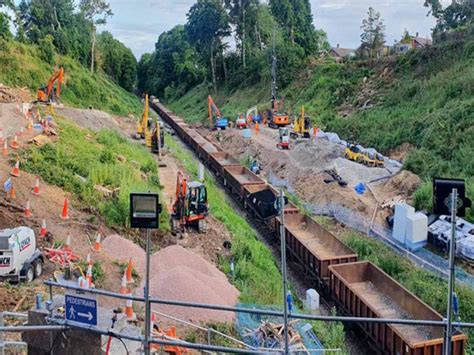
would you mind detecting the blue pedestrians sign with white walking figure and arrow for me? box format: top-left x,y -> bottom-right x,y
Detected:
65,291 -> 98,326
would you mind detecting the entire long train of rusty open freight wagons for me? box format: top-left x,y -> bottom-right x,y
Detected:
151,101 -> 467,355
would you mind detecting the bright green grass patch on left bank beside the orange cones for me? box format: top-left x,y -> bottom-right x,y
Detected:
22,116 -> 168,229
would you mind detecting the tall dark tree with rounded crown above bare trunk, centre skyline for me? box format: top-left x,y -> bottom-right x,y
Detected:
185,0 -> 230,93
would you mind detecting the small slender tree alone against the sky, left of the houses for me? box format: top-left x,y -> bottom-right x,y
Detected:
360,7 -> 385,58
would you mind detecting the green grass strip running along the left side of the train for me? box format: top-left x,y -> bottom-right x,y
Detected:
166,136 -> 347,353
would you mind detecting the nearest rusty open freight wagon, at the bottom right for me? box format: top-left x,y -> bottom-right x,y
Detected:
329,261 -> 467,355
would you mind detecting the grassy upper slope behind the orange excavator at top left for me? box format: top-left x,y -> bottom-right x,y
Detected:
0,41 -> 142,117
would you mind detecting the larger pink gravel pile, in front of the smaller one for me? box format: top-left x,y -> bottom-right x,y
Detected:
150,245 -> 239,323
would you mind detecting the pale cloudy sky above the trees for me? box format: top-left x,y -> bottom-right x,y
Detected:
102,0 -> 450,58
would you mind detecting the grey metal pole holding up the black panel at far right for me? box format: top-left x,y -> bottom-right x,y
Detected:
444,189 -> 458,355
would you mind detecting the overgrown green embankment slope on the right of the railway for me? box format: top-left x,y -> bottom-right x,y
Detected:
170,39 -> 474,220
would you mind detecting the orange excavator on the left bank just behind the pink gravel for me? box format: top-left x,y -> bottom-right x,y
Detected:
171,171 -> 209,235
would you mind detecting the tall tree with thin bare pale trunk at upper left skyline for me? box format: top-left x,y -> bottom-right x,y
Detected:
79,0 -> 113,73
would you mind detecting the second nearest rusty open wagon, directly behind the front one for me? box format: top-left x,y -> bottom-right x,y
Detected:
275,213 -> 357,285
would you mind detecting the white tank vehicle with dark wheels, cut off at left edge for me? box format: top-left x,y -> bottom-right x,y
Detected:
0,227 -> 44,282
